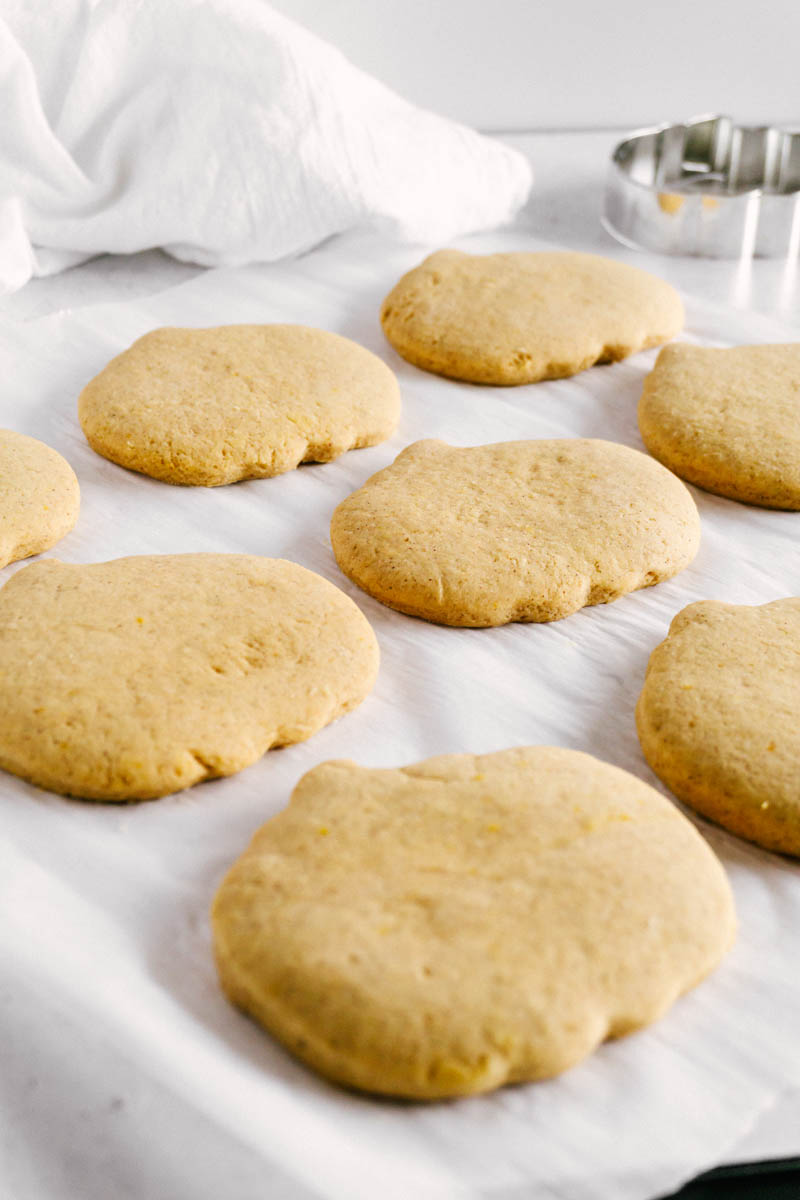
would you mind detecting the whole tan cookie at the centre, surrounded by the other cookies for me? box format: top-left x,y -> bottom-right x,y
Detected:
331,438 -> 699,626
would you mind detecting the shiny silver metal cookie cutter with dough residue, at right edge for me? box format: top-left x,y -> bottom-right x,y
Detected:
602,115 -> 800,259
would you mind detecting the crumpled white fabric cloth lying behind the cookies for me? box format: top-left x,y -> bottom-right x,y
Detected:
0,0 -> 530,292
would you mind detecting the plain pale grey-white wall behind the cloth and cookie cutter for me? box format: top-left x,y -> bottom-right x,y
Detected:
275,0 -> 800,131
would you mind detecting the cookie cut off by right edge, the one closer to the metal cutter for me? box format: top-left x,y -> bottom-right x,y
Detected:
639,342 -> 800,509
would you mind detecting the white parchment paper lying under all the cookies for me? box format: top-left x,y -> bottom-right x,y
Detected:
0,233 -> 800,1200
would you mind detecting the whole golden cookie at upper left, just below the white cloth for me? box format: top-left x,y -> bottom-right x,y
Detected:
78,325 -> 399,487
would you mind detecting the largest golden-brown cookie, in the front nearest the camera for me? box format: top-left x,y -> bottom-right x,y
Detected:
212,746 -> 735,1099
